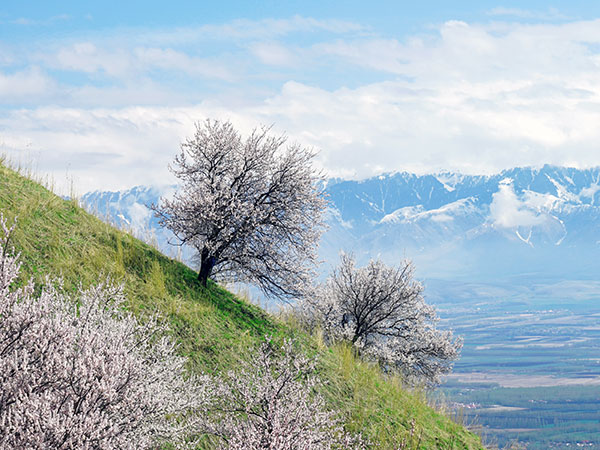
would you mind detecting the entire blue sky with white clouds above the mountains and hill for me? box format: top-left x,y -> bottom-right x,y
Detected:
0,1 -> 600,192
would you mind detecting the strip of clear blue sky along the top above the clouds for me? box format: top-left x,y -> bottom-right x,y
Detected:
0,0 -> 600,40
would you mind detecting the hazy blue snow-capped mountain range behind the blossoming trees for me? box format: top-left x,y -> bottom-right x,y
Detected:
82,166 -> 600,280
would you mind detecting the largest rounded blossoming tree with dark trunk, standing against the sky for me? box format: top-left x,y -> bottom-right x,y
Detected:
152,120 -> 325,298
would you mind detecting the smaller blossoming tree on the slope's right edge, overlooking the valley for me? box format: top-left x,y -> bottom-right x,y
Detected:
303,254 -> 462,385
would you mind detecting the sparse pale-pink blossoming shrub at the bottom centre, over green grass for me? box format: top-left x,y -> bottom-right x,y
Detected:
210,339 -> 360,450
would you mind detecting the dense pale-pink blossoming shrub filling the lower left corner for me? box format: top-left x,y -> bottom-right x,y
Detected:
0,215 -> 209,449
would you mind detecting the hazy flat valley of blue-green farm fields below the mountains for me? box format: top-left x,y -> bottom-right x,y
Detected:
429,280 -> 600,450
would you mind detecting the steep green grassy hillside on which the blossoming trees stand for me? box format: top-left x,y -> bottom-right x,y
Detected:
0,164 -> 482,449
